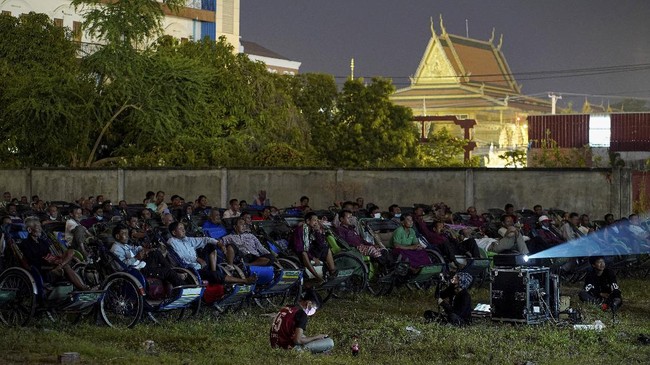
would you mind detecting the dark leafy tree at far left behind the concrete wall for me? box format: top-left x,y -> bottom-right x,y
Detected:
0,13 -> 93,166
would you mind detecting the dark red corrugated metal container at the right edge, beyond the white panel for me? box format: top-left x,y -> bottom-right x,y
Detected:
609,113 -> 650,151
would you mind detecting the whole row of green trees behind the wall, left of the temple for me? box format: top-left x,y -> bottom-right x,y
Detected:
0,5 -> 468,168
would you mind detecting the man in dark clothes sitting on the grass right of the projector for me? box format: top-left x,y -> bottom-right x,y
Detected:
578,256 -> 623,311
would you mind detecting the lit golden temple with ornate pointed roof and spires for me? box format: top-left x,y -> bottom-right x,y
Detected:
391,16 -> 551,166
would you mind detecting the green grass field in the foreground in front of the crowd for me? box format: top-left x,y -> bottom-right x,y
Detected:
0,279 -> 650,365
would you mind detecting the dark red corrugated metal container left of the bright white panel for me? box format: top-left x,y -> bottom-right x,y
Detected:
528,114 -> 589,148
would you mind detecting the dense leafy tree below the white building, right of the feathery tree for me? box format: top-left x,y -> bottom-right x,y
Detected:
149,38 -> 309,166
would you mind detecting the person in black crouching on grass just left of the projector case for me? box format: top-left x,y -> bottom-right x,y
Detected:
424,272 -> 473,326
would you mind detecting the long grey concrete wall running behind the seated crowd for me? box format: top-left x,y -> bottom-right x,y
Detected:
0,169 -> 632,219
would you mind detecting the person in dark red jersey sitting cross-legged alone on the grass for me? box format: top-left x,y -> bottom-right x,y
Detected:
270,290 -> 334,354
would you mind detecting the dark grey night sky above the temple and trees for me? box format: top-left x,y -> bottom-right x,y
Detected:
240,0 -> 650,109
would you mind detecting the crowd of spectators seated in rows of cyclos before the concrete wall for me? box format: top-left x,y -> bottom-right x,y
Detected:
0,190 -> 650,336
